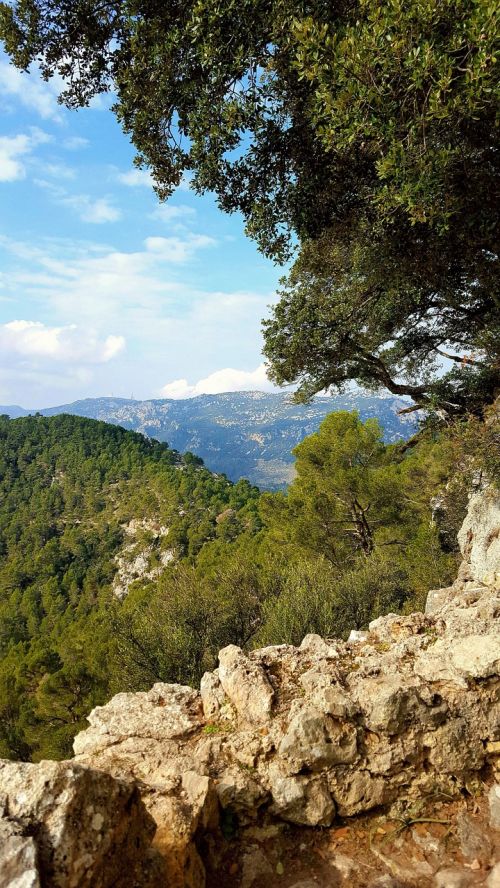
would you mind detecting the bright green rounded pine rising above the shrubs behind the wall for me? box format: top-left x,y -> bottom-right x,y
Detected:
263,412 -> 405,568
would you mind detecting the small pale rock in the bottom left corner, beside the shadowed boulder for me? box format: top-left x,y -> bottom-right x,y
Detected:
0,817 -> 40,888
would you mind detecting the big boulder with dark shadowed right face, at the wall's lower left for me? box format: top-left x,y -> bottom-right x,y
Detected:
0,762 -> 154,888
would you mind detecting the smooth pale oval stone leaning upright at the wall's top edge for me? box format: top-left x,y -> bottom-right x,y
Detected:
219,644 -> 274,725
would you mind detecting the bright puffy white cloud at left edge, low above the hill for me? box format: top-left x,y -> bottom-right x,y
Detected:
0,320 -> 125,365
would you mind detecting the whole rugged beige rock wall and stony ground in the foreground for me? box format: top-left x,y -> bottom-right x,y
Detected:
0,490 -> 500,888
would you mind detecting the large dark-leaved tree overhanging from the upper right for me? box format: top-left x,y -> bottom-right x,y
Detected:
0,0 -> 500,409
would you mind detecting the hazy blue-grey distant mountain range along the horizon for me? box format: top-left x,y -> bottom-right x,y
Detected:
0,392 -> 416,490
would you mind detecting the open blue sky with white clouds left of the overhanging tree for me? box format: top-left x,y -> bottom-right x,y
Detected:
0,52 -> 282,408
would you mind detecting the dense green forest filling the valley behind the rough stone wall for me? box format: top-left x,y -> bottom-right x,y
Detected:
0,412 -> 498,759
